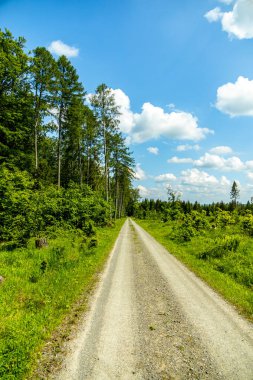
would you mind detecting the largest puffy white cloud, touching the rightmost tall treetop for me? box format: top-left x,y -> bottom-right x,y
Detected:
112,89 -> 212,143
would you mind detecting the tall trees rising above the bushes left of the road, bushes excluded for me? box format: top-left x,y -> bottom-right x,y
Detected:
0,29 -> 134,243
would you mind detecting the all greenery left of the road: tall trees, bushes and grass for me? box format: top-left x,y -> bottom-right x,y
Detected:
0,30 -> 137,379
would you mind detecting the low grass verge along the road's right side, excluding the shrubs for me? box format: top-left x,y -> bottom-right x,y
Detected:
136,220 -> 253,321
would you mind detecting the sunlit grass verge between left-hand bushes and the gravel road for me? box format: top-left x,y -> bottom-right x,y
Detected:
0,220 -> 124,380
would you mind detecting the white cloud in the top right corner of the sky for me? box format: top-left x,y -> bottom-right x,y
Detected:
205,0 -> 253,39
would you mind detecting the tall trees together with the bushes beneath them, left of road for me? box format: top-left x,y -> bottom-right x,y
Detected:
0,30 -> 135,245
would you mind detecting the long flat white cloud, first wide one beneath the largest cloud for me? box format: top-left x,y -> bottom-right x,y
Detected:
168,153 -> 247,171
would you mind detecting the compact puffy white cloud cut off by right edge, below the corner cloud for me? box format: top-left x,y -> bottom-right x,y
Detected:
216,76 -> 253,117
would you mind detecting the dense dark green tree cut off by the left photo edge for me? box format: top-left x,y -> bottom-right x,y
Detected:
0,30 -> 32,170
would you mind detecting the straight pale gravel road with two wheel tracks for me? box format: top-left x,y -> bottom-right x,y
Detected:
54,220 -> 253,380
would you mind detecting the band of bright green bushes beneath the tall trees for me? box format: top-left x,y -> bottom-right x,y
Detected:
0,168 -> 110,244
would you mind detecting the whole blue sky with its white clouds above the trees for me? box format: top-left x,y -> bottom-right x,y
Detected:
0,0 -> 253,203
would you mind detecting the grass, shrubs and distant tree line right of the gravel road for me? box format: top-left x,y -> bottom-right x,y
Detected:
134,189 -> 253,320
